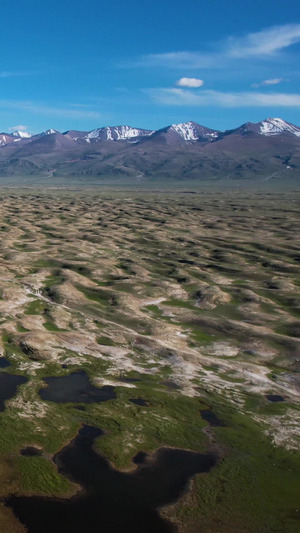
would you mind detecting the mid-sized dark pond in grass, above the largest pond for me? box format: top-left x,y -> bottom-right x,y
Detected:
39,370 -> 116,403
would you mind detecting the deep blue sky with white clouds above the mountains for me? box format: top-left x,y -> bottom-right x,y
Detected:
0,0 -> 300,133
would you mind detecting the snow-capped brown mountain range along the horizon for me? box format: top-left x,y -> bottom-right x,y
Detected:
0,118 -> 300,182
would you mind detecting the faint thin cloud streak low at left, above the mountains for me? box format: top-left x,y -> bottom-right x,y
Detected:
0,100 -> 101,119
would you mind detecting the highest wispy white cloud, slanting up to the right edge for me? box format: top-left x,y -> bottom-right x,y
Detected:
130,24 -> 300,69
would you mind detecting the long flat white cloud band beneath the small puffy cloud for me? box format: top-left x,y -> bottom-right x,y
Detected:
144,88 -> 300,108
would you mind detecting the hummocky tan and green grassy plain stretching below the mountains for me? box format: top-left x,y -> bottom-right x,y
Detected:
0,187 -> 300,533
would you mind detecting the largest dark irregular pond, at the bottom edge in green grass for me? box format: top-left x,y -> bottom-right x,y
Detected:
6,426 -> 217,533
